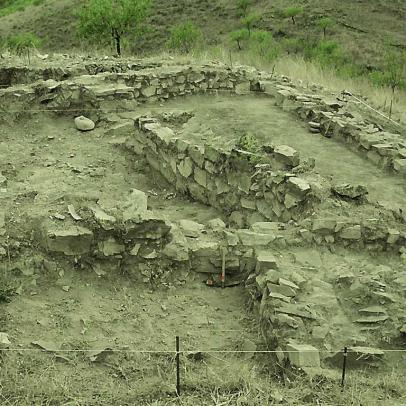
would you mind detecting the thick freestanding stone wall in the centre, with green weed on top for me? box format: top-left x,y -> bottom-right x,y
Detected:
133,117 -> 316,227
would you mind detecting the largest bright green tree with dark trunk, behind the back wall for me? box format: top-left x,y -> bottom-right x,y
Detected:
78,0 -> 151,56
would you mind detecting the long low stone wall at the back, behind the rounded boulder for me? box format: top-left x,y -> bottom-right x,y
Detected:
0,66 -> 254,116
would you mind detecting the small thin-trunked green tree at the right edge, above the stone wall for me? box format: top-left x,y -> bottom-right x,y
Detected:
370,51 -> 406,118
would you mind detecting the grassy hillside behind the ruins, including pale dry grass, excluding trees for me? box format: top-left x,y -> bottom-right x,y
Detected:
0,0 -> 406,121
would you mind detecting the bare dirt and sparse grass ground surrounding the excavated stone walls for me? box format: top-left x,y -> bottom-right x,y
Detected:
0,58 -> 406,406
